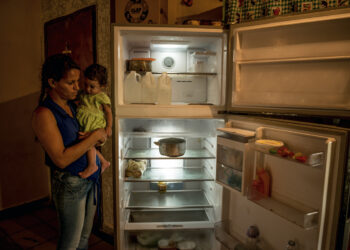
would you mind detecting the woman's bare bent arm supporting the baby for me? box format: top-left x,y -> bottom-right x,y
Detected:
32,107 -> 106,168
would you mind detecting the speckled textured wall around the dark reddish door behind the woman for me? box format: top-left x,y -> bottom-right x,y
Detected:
41,0 -> 113,233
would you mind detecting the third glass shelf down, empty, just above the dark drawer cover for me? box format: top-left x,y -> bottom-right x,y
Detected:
126,190 -> 212,209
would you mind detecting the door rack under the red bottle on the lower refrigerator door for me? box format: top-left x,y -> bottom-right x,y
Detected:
248,190 -> 319,229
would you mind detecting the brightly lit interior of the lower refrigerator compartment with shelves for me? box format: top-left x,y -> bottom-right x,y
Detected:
118,118 -> 224,250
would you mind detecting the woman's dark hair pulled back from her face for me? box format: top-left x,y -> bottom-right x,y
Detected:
39,54 -> 80,105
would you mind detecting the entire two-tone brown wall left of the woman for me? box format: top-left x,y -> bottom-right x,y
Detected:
0,0 -> 49,210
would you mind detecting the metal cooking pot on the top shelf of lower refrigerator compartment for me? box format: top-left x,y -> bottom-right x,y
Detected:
154,138 -> 186,157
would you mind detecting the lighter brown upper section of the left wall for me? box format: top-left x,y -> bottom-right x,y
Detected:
0,0 -> 42,103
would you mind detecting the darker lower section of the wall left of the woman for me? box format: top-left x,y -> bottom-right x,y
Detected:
0,93 -> 50,210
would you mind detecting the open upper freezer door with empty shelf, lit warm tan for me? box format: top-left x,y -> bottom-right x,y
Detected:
227,10 -> 350,116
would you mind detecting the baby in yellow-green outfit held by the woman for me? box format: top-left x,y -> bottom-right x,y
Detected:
77,64 -> 112,178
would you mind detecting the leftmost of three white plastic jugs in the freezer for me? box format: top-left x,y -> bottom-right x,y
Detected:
124,71 -> 142,104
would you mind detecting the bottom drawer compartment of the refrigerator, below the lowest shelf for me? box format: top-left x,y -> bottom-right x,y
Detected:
125,229 -> 218,250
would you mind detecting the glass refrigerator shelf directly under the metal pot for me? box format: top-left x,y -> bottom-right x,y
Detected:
124,148 -> 215,159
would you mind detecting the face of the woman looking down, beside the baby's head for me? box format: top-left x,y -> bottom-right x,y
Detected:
53,69 -> 80,100
